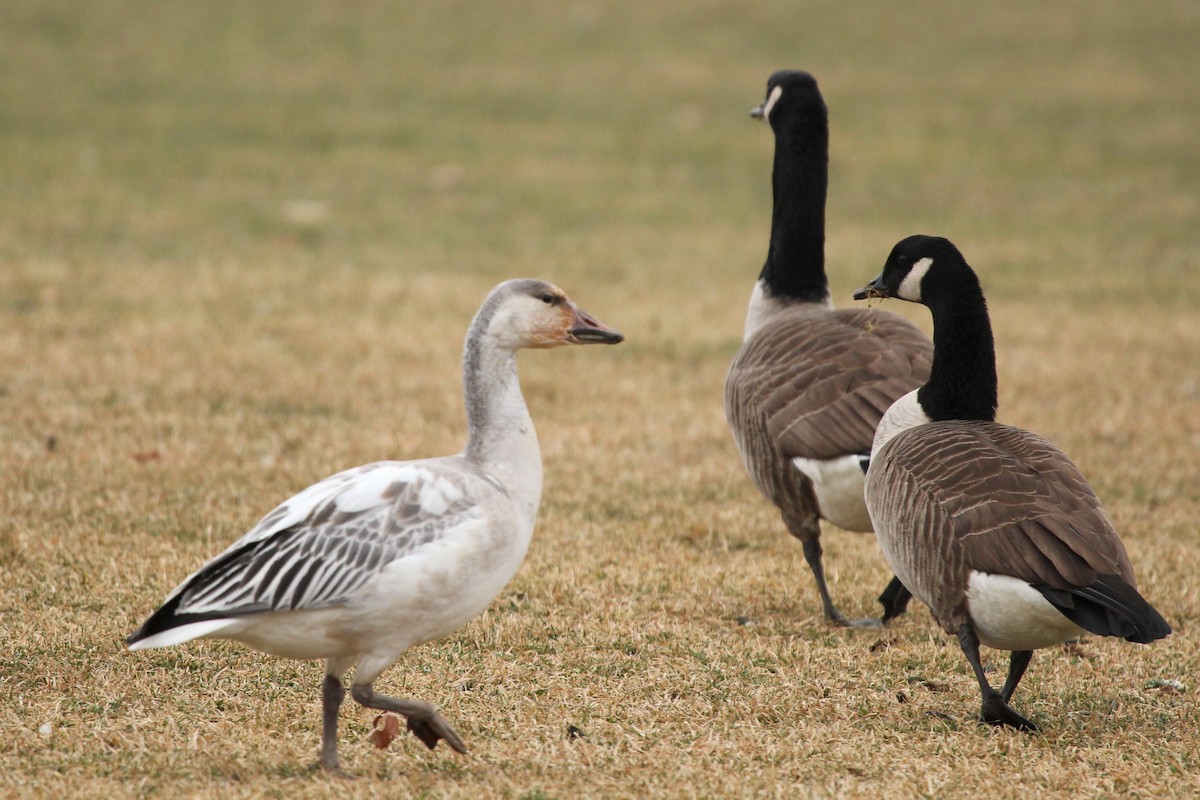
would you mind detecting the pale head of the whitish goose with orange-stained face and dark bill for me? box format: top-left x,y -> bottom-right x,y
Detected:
485,278 -> 625,350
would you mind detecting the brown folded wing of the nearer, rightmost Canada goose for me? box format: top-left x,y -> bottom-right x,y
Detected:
883,421 -> 1136,590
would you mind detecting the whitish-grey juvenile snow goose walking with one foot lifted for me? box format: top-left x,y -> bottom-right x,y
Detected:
126,279 -> 623,769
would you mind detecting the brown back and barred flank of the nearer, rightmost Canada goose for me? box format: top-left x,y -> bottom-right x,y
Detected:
866,412 -> 1136,632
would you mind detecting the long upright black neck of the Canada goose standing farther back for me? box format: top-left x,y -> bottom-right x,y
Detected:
760,119 -> 829,302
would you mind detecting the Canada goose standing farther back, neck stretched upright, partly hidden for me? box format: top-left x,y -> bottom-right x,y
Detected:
725,71 -> 934,625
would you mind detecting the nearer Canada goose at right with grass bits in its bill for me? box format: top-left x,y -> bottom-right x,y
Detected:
854,236 -> 1171,730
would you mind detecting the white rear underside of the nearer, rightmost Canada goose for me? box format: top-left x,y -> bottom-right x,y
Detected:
967,571 -> 1084,650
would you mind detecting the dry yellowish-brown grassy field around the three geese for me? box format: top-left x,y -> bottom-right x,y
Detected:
0,0 -> 1200,800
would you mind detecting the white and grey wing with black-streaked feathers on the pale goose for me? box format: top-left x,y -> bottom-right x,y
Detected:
130,462 -> 482,642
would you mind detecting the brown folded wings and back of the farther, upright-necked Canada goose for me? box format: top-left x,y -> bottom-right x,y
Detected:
726,308 -> 934,459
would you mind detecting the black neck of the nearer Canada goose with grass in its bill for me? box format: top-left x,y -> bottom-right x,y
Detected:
917,270 -> 998,421
